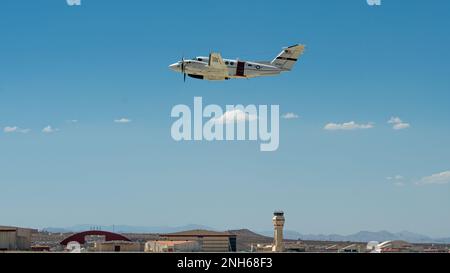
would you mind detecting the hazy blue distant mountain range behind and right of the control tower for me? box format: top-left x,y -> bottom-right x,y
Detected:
262,230 -> 450,244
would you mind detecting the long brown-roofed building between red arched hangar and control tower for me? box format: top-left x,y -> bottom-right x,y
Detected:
160,230 -> 237,252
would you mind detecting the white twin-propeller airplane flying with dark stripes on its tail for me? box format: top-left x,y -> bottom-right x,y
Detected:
169,44 -> 305,81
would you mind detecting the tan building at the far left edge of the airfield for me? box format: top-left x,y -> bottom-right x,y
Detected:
0,226 -> 38,251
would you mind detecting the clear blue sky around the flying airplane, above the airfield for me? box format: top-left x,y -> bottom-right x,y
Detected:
0,0 -> 450,237
